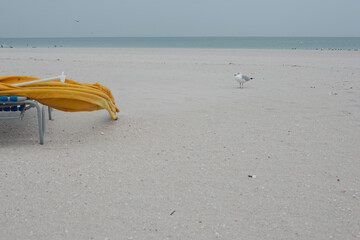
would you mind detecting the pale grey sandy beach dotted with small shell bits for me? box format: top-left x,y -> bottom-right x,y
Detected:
0,48 -> 360,240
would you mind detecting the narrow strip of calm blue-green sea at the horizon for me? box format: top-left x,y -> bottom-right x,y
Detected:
0,37 -> 360,51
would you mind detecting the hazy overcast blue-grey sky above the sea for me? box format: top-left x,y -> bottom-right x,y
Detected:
0,0 -> 360,37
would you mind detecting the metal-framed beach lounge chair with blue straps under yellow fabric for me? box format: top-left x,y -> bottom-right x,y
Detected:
0,96 -> 52,144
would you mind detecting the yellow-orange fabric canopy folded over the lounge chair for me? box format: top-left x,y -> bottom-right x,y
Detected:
0,76 -> 120,120
